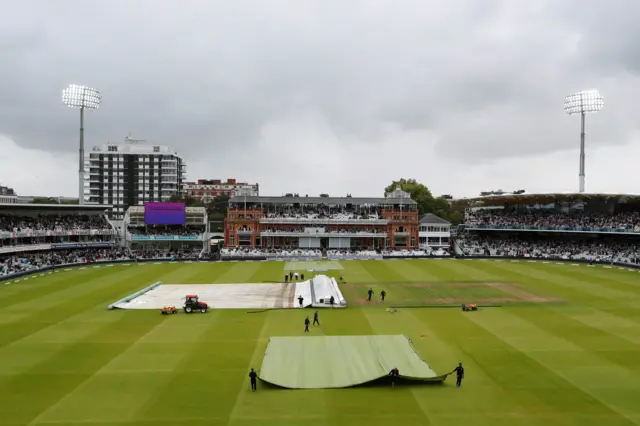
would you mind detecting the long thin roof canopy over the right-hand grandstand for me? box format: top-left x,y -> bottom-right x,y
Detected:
454,193 -> 640,207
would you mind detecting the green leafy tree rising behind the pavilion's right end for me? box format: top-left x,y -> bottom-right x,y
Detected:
384,178 -> 462,225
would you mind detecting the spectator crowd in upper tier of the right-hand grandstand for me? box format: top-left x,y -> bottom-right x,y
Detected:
465,209 -> 640,232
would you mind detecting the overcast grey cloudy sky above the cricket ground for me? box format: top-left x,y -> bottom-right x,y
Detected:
0,0 -> 640,200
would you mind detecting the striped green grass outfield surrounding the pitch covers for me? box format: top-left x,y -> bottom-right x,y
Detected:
0,260 -> 640,426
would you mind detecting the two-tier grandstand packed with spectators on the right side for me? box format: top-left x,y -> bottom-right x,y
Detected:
454,194 -> 640,265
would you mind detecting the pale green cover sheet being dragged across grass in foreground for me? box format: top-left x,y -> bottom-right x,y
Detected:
259,335 -> 447,389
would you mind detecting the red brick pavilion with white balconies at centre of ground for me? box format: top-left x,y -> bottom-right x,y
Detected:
224,190 -> 420,250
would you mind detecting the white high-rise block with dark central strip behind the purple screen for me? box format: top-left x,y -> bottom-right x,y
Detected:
84,137 -> 187,220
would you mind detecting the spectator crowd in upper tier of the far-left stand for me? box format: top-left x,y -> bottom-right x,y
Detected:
0,214 -> 111,232
